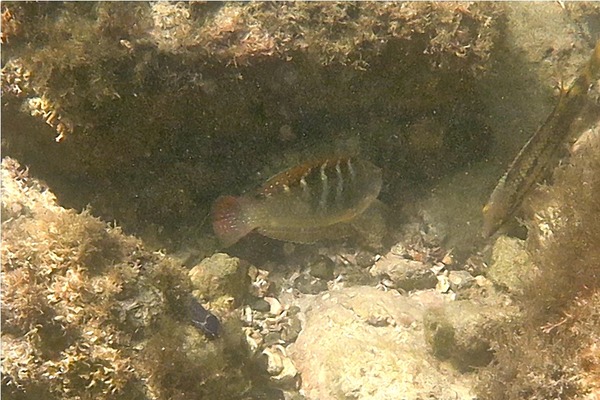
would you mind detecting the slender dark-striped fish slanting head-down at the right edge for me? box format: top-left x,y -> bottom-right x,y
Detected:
482,41 -> 600,238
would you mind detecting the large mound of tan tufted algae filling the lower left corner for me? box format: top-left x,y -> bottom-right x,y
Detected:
1,158 -> 270,399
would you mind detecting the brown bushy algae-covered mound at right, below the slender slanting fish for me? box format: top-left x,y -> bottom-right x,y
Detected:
480,124 -> 600,399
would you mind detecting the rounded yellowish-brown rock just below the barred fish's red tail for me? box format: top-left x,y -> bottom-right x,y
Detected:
189,253 -> 250,304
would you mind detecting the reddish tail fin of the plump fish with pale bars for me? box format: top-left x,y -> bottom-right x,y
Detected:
212,196 -> 256,247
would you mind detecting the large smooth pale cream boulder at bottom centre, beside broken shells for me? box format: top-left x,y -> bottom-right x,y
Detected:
288,287 -> 473,400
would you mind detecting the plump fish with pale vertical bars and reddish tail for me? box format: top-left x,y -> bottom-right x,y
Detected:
212,155 -> 382,247
